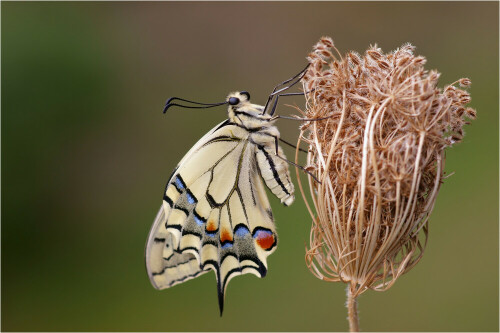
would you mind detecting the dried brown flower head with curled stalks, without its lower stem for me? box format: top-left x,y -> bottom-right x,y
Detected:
299,37 -> 476,304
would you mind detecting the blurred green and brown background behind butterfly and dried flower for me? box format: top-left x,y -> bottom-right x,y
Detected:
1,2 -> 499,331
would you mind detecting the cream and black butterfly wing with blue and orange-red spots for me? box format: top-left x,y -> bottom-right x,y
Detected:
146,121 -> 277,313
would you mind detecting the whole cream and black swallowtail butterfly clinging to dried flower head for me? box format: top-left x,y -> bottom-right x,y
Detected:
145,67 -> 307,315
